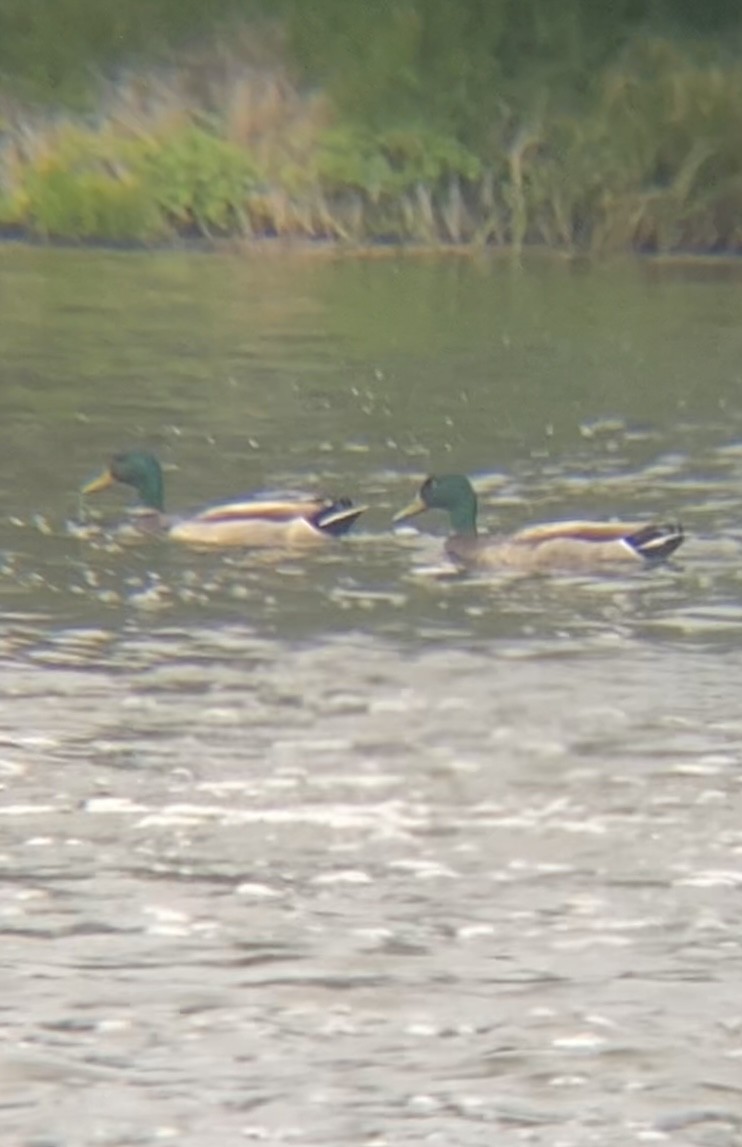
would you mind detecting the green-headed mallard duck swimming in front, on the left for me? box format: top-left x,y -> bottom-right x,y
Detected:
80,451 -> 366,546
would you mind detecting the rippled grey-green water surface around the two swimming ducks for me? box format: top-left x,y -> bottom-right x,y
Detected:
0,248 -> 742,1147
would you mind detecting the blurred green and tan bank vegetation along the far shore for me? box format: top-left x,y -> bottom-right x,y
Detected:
0,0 -> 742,252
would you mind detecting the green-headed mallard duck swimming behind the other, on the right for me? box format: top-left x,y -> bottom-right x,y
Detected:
395,474 -> 684,571
